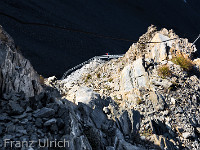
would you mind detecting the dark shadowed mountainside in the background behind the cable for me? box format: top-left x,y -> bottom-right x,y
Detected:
0,0 -> 200,78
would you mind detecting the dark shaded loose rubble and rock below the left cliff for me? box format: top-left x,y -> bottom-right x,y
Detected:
0,91 -> 149,150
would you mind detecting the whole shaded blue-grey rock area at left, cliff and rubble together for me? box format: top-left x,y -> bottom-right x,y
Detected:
0,27 -> 159,150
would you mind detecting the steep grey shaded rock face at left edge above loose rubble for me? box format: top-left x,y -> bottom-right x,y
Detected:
0,26 -> 42,97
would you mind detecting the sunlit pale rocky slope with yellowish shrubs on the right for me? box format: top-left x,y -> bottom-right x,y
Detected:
45,26 -> 200,149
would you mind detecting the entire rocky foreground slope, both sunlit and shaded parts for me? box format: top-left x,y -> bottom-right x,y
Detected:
0,26 -> 200,150
